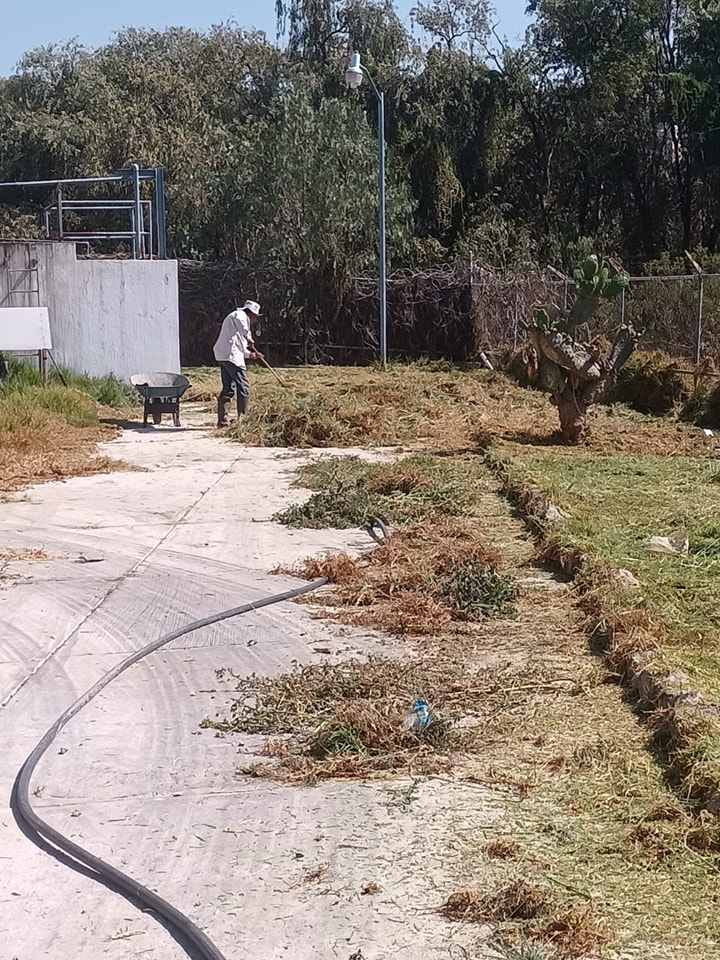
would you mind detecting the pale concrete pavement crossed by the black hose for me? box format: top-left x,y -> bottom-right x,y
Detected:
0,410 -> 502,960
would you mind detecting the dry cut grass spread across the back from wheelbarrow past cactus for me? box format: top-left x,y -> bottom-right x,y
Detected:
186,363 -> 703,455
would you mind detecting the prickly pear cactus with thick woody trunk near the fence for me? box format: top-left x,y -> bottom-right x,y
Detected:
526,255 -> 639,444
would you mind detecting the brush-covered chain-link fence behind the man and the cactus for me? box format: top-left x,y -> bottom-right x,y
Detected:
180,261 -> 720,365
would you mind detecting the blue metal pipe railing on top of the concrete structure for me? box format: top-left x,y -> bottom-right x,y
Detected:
0,163 -> 167,260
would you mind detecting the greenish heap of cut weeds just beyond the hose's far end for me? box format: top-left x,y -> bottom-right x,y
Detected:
273,454 -> 474,529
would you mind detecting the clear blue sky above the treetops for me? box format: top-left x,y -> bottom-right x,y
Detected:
0,0 -> 527,75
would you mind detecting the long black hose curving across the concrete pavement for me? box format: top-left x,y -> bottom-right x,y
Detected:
10,578 -> 328,960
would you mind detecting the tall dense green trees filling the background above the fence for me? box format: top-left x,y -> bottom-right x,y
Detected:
0,0 -> 720,278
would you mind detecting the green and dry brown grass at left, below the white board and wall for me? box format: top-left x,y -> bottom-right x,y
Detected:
0,363 -> 134,492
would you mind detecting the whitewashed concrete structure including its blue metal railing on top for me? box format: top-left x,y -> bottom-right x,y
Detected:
0,164 -> 180,379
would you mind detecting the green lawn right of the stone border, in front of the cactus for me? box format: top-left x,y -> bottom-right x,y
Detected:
515,450 -> 720,698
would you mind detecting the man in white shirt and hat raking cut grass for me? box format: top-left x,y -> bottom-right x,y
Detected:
213,300 -> 262,427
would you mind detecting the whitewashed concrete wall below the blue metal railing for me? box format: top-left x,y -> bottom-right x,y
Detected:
0,242 -> 180,380
